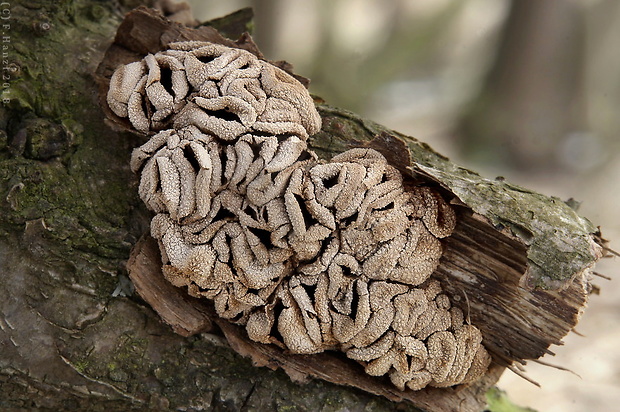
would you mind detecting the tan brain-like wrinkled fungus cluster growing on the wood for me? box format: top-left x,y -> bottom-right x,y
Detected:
108,42 -> 490,390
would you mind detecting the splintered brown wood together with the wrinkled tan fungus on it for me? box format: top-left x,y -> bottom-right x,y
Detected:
108,9 -> 601,410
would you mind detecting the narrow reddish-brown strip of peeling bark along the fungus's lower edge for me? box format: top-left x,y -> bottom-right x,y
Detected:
128,236 -> 504,411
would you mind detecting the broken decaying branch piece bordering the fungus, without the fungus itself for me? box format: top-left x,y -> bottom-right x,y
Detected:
100,6 -> 602,410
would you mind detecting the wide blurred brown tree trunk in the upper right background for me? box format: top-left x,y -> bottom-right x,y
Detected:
459,0 -> 587,170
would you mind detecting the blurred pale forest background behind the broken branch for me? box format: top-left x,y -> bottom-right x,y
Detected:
190,0 -> 620,412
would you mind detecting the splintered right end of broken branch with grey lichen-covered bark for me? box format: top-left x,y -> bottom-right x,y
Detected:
358,135 -> 603,362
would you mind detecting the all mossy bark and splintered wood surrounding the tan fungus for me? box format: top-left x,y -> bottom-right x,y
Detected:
0,0 -> 602,411
